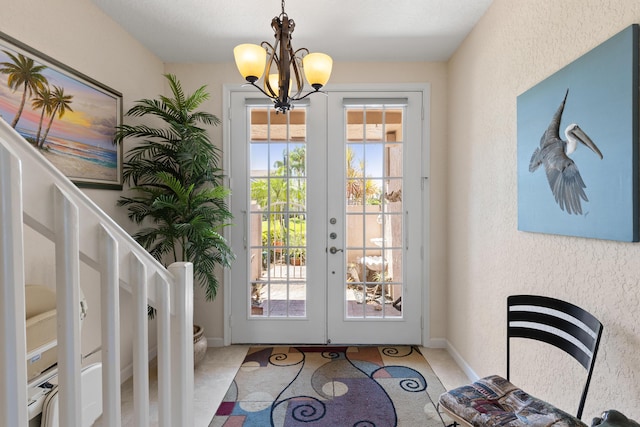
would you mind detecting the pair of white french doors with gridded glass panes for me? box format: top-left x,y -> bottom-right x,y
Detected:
226,91 -> 423,344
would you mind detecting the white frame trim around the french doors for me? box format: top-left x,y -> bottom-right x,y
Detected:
222,83 -> 431,345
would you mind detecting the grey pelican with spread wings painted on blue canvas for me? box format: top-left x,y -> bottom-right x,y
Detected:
529,89 -> 603,215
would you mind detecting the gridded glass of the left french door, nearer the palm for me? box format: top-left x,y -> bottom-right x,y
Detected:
247,107 -> 307,318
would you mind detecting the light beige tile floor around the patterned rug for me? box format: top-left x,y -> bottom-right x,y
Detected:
112,345 -> 469,427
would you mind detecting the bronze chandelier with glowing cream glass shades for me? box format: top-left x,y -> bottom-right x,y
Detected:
233,0 -> 333,113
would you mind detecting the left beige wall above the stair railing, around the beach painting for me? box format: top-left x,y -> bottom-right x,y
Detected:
0,0 -> 164,228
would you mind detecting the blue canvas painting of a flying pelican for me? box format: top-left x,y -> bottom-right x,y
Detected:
517,25 -> 639,242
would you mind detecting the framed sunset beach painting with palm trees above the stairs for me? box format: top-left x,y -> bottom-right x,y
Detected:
0,33 -> 122,189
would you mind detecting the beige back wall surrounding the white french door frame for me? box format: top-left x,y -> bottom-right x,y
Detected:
166,62 -> 447,343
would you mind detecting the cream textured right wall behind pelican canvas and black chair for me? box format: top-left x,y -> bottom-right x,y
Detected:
447,0 -> 640,422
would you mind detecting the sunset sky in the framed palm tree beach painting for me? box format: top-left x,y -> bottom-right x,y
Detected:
0,45 -> 118,150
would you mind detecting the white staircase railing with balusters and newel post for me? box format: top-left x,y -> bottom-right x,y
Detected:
0,120 -> 194,427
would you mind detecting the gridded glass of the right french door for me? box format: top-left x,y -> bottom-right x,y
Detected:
344,106 -> 404,319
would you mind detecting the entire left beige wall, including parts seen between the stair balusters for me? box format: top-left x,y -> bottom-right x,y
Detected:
0,0 -> 164,380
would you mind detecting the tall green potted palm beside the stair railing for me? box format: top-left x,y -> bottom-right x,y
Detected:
115,74 -> 235,364
